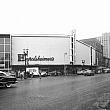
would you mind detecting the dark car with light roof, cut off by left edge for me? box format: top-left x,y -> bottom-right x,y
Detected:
0,71 -> 18,87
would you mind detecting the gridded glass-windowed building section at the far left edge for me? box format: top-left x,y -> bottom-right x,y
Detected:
0,34 -> 11,71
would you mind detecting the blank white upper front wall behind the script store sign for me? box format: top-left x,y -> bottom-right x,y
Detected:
12,35 -> 70,65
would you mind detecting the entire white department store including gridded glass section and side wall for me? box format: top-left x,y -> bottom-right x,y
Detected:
0,34 -> 95,73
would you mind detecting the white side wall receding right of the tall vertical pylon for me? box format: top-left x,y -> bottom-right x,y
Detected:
75,41 -> 95,65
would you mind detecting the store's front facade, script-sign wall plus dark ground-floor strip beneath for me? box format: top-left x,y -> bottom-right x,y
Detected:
11,34 -> 73,74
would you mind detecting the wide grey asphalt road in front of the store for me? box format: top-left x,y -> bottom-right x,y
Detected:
0,74 -> 110,110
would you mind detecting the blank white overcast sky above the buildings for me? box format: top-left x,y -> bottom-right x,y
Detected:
0,0 -> 110,39
